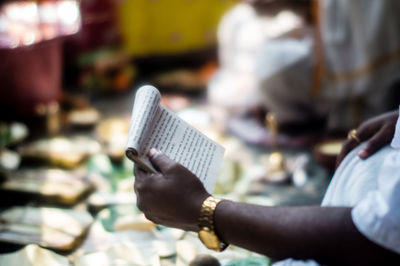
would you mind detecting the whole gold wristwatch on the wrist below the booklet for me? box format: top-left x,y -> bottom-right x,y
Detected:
198,196 -> 228,252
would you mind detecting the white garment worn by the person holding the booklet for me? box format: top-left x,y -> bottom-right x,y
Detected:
274,108 -> 400,266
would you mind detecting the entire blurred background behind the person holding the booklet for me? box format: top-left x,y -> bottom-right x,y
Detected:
0,0 -> 400,265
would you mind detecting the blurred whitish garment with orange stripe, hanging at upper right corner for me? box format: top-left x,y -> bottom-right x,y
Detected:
320,0 -> 400,128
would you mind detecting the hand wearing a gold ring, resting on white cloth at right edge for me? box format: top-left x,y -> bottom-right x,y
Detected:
336,111 -> 399,167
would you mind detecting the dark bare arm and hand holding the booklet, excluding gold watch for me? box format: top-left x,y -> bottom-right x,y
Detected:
135,151 -> 399,265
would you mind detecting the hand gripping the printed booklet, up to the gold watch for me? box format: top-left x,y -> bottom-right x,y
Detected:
134,149 -> 209,231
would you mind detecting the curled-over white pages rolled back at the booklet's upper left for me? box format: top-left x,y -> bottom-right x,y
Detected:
127,85 -> 161,156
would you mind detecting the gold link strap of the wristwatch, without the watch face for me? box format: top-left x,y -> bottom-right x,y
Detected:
199,196 -> 228,251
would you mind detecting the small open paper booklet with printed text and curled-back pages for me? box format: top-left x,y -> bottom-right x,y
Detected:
126,85 -> 224,193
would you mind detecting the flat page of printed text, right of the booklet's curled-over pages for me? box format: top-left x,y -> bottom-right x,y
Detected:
139,105 -> 224,193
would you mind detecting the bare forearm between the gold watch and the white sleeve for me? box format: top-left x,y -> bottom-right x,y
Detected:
215,201 -> 398,265
